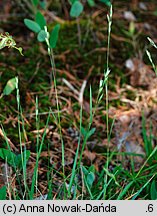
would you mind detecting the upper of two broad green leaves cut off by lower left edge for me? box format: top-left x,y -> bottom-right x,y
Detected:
0,148 -> 16,166
